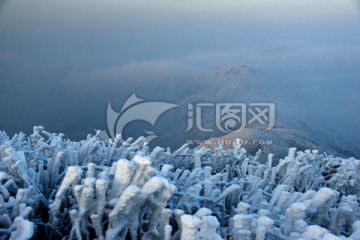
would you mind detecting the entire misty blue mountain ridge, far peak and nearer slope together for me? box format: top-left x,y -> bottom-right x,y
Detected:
54,65 -> 360,161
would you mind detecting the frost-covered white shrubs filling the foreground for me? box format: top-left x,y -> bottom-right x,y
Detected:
0,127 -> 360,240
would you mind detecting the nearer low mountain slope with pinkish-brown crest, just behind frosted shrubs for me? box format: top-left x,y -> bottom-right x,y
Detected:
198,120 -> 360,161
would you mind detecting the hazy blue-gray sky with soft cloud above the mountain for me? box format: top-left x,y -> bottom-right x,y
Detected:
0,0 -> 360,142
